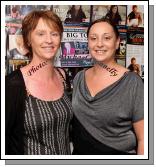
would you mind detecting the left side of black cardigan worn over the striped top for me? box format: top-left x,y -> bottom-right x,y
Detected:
5,70 -> 71,155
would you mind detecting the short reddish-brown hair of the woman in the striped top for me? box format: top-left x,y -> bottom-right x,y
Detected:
22,10 -> 63,58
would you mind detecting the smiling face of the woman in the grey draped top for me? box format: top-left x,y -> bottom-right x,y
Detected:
88,22 -> 120,63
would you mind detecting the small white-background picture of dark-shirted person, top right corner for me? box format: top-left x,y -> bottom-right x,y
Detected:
127,5 -> 144,27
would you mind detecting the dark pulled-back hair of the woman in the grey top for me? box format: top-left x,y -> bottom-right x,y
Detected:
87,17 -> 119,38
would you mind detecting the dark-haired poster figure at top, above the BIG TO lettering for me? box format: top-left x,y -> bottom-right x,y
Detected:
64,5 -> 86,23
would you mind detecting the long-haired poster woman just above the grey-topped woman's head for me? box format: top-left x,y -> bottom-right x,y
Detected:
105,5 -> 122,25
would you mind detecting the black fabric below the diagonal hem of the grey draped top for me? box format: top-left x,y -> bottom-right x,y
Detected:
72,116 -> 136,155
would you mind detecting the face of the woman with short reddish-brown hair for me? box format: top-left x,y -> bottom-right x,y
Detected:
30,18 -> 61,59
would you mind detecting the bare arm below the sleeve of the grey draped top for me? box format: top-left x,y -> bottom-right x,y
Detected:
133,120 -> 144,155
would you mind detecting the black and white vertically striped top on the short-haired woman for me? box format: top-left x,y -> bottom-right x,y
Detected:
24,93 -> 72,155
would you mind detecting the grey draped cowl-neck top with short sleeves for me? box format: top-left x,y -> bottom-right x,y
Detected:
72,70 -> 144,153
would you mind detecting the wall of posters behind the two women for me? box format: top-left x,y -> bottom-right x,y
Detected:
5,5 -> 144,78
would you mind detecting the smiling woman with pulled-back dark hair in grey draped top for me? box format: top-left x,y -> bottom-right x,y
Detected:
72,19 -> 144,155
